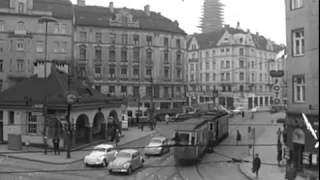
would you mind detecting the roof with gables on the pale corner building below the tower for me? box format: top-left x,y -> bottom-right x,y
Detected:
187,27 -> 283,52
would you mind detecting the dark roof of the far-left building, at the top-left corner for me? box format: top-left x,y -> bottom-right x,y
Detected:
0,0 -> 73,19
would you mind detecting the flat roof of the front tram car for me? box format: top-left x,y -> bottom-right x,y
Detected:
174,117 -> 208,131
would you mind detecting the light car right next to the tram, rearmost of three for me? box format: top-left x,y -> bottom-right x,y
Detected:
144,137 -> 170,155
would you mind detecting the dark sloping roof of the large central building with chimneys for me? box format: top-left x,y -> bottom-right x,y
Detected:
74,5 -> 186,35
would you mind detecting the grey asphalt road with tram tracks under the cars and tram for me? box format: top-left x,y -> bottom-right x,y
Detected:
0,113 -> 282,180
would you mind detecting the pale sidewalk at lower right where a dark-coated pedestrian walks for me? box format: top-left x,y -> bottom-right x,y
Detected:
239,114 -> 304,180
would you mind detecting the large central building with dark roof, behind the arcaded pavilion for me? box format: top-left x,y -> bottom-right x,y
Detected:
74,1 -> 186,109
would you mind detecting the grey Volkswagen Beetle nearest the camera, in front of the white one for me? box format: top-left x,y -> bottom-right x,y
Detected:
108,149 -> 144,174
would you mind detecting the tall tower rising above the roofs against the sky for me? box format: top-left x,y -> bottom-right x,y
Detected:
198,0 -> 224,33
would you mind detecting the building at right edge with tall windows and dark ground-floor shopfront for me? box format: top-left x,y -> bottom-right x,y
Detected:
285,0 -> 319,178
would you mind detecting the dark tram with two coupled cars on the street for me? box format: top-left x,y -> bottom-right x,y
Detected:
174,112 -> 229,161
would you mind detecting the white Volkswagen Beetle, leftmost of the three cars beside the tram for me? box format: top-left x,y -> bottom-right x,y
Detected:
83,144 -> 118,166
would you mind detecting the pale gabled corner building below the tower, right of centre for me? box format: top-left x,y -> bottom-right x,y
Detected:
187,24 -> 283,109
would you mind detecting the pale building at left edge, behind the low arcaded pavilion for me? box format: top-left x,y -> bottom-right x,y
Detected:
0,0 -> 73,91
